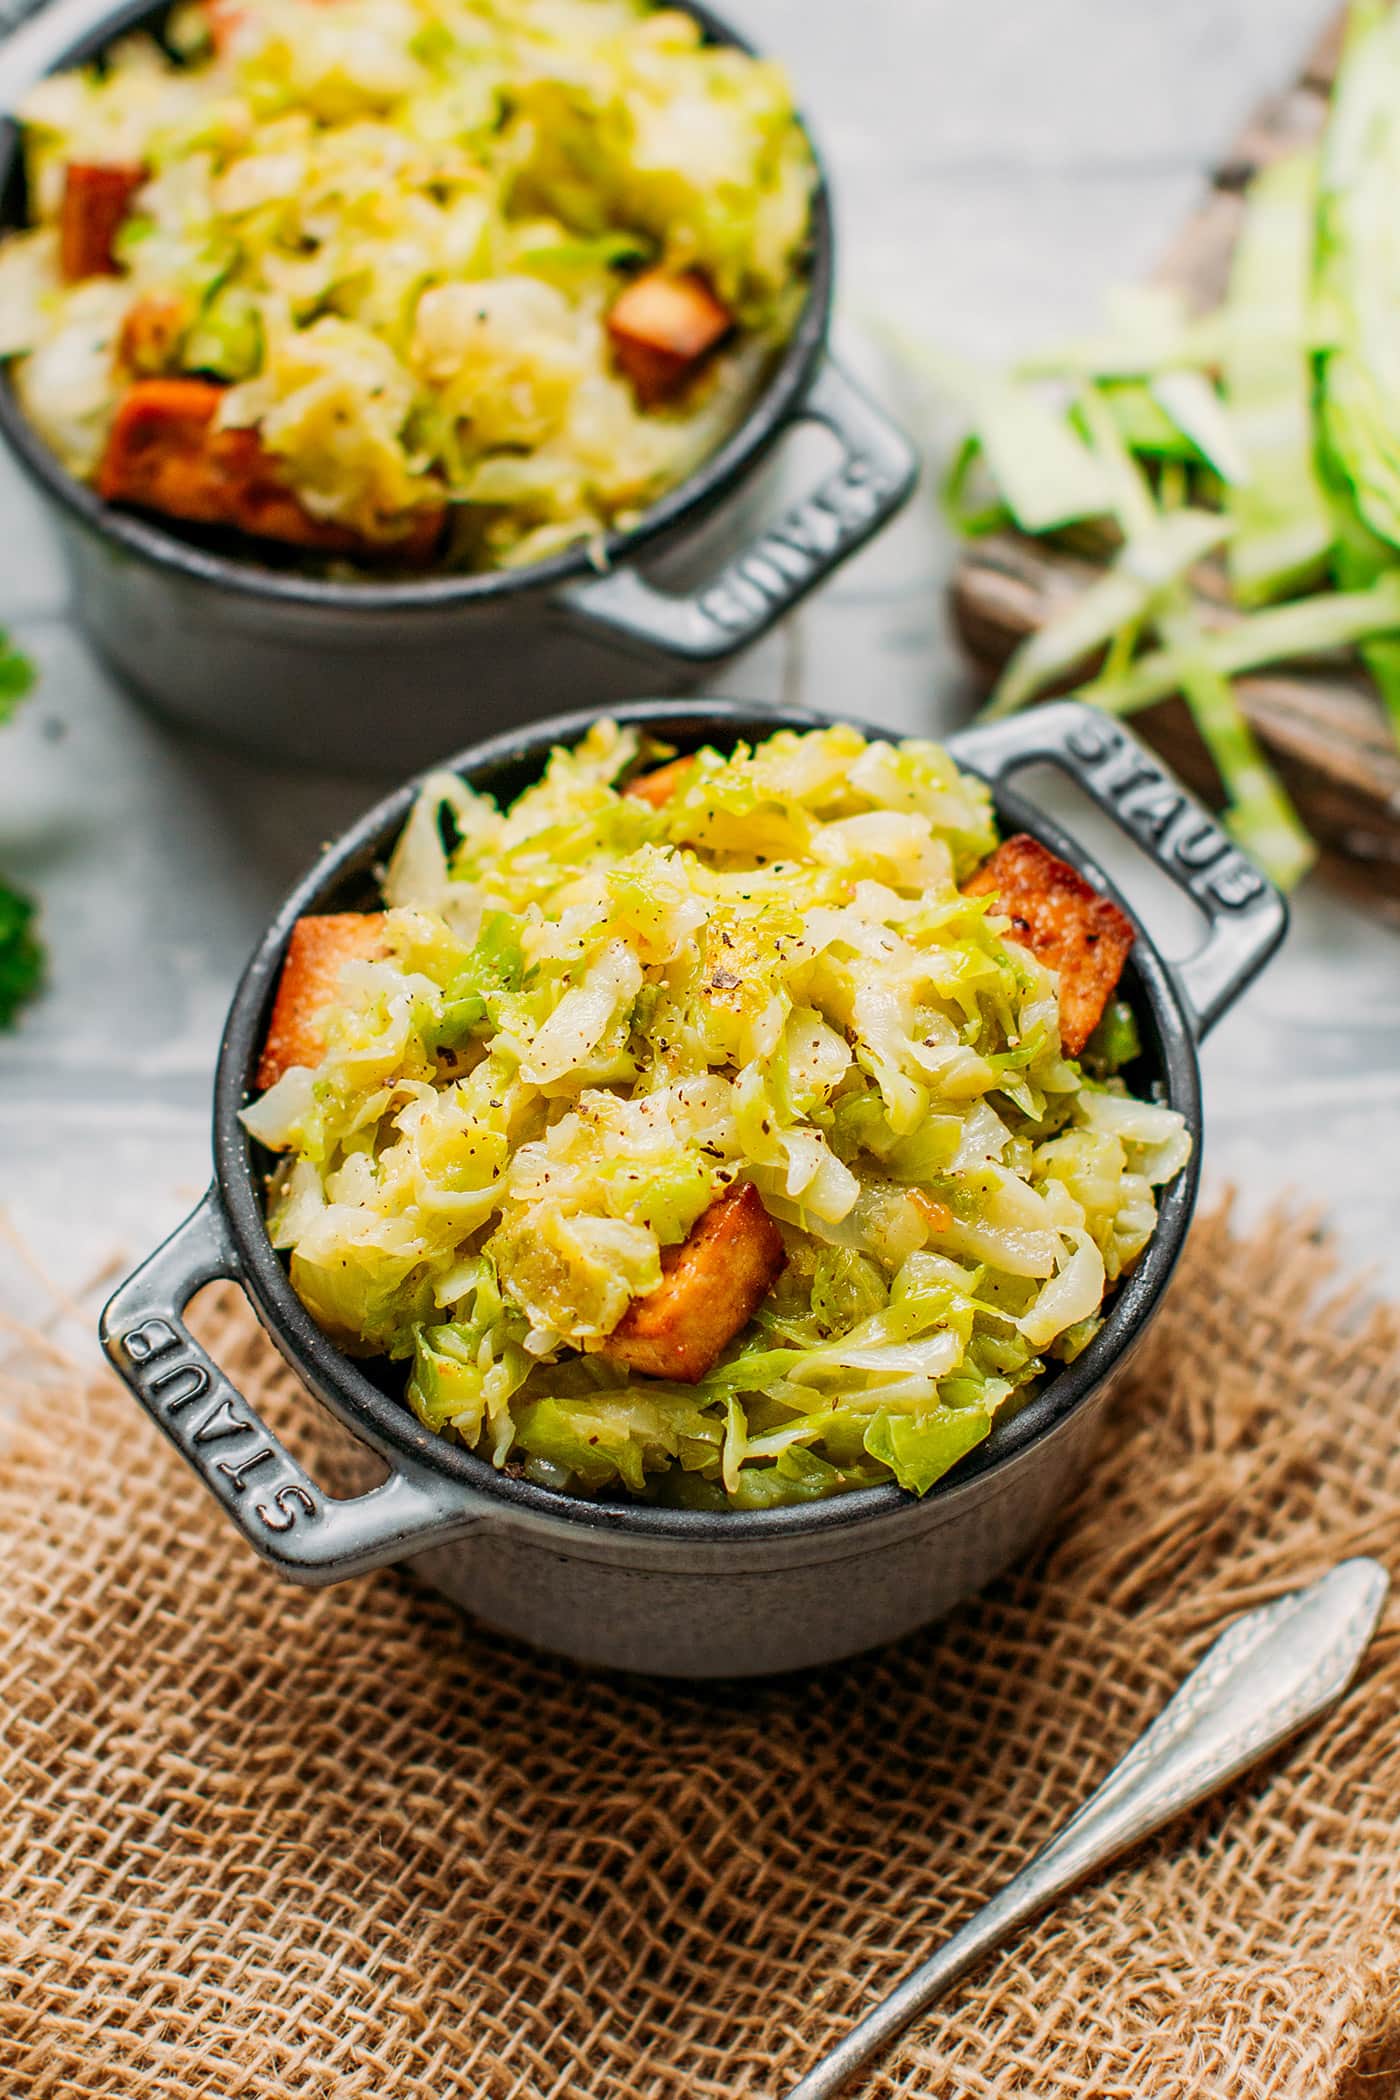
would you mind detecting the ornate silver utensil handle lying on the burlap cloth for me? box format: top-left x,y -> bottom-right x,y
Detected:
787,1558 -> 1390,2100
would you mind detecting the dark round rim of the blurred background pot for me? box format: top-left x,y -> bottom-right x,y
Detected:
0,0 -> 835,613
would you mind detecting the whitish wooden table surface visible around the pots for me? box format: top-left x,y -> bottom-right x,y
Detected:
0,0 -> 1400,1315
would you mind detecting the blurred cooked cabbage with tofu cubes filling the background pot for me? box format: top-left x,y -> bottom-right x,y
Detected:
0,0 -> 814,569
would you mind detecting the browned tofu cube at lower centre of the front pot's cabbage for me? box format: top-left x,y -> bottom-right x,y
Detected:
598,1182 -> 785,1386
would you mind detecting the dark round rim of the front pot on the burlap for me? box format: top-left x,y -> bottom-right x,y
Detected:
214,701 -> 1201,1544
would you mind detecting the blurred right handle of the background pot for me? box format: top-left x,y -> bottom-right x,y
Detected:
560,357 -> 919,664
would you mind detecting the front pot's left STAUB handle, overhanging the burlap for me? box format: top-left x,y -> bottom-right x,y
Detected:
101,1189 -> 485,1586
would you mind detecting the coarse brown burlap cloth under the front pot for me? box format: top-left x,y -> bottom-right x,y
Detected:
0,1216 -> 1400,2100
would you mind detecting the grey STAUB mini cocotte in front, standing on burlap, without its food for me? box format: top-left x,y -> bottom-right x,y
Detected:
103,701 -> 1287,1678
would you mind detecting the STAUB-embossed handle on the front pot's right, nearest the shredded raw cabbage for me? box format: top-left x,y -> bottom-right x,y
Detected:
949,699 -> 1289,1042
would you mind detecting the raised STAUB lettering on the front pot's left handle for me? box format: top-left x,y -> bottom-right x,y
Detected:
120,1319 -> 319,1531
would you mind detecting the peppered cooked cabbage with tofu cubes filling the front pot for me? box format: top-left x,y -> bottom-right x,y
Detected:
243,722 -> 1190,1510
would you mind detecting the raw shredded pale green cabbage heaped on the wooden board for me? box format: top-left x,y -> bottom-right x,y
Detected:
909,0 -> 1400,888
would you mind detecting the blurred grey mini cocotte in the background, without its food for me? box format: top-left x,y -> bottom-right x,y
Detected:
0,0 -> 917,773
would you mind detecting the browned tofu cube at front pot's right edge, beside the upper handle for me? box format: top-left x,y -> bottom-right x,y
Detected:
963,832 -> 1133,1056
